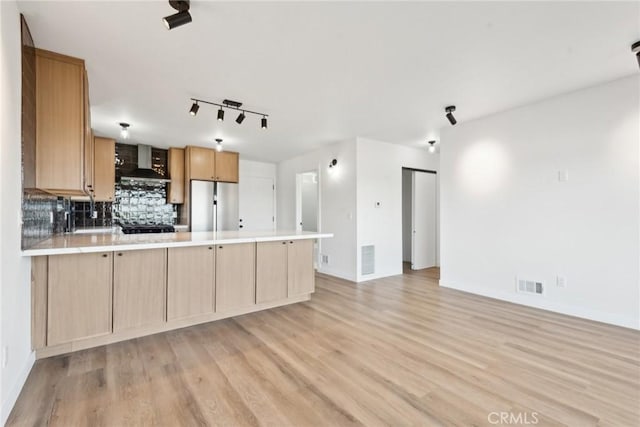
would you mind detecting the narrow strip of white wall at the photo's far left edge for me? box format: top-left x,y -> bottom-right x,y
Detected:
0,1 -> 34,425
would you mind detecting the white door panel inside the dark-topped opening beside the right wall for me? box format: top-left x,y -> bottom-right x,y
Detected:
411,171 -> 436,270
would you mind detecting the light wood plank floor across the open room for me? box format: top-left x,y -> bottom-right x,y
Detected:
8,270 -> 640,426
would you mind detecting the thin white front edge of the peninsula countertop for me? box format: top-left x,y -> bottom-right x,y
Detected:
21,233 -> 333,257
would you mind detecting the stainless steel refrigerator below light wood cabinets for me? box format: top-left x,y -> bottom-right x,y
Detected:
190,180 -> 242,231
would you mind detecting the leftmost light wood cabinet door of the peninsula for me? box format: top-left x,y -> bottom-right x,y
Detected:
47,252 -> 113,345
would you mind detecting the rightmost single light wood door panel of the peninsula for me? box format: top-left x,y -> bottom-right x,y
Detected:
287,239 -> 316,297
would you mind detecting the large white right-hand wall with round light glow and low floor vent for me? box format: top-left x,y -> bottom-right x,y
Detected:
440,76 -> 640,328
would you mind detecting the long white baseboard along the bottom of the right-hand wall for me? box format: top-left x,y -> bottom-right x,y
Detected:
440,281 -> 640,330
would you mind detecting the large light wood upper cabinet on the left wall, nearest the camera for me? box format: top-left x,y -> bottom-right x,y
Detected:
36,49 -> 91,196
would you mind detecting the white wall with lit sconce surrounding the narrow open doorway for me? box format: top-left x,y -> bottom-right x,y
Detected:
277,140 -> 356,280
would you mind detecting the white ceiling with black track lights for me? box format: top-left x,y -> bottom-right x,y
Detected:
19,1 -> 640,161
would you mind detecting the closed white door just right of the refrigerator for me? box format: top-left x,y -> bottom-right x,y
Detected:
238,176 -> 275,231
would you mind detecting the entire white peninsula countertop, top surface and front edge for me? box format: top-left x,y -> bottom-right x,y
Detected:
22,230 -> 333,256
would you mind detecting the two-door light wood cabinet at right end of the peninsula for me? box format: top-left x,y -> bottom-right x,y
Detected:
256,240 -> 315,304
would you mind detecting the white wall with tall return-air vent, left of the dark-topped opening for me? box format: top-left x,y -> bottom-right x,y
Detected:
357,138 -> 439,281
